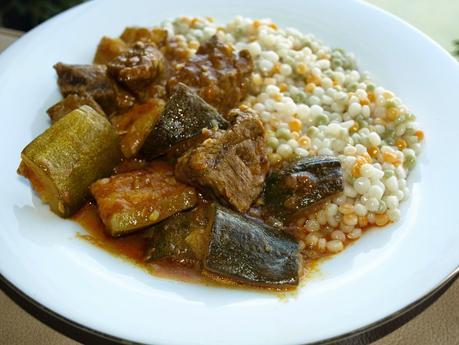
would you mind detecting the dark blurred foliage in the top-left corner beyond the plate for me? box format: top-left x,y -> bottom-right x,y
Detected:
0,0 -> 83,31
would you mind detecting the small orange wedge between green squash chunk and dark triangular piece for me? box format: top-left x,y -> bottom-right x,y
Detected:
111,99 -> 165,158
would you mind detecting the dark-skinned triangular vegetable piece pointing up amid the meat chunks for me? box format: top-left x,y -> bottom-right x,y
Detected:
140,83 -> 228,160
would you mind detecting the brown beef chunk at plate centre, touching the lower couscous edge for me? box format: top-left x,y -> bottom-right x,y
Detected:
175,112 -> 268,212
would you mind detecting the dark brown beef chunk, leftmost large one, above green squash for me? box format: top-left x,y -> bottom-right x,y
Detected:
54,63 -> 135,115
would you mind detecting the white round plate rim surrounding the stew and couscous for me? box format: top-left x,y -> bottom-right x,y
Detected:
0,0 -> 459,345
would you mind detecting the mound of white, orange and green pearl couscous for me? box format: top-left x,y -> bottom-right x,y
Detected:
162,17 -> 424,258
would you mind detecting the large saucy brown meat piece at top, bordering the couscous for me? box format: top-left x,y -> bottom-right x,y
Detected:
168,36 -> 253,114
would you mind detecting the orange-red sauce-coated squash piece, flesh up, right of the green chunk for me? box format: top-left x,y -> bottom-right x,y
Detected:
91,161 -> 197,237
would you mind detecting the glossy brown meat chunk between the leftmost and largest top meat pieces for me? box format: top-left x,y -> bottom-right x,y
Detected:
108,41 -> 164,91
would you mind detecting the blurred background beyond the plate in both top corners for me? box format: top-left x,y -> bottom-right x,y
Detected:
0,0 -> 459,57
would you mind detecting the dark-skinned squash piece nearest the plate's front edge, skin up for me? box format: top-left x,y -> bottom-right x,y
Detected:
204,208 -> 300,287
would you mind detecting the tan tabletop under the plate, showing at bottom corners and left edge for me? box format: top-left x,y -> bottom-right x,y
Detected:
0,18 -> 459,345
